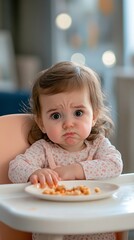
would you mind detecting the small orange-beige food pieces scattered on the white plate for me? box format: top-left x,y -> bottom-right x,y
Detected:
42,185 -> 101,196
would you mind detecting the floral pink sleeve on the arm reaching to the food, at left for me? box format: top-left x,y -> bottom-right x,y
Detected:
8,140 -> 47,183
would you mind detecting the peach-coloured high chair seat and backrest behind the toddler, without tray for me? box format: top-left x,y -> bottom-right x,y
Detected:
0,114 -> 128,240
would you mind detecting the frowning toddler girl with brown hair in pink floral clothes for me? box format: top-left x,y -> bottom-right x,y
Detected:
9,61 -> 123,240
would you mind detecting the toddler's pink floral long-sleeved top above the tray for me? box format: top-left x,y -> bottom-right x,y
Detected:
8,135 -> 123,183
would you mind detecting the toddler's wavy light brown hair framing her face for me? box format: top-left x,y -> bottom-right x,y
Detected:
29,61 -> 113,143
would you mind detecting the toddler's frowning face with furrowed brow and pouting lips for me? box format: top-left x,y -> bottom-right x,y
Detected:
37,89 -> 96,151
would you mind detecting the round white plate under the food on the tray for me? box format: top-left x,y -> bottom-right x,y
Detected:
25,180 -> 119,201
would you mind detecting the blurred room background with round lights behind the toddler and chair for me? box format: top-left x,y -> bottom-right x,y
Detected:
0,0 -> 134,176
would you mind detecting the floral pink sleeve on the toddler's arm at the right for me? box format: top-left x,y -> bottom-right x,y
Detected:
80,137 -> 123,179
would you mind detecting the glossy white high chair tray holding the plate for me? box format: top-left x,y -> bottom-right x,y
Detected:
0,173 -> 134,234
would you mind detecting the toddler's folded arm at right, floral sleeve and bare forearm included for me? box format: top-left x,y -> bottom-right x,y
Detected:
55,138 -> 123,180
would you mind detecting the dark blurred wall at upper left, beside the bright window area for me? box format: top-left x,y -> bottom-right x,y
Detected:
0,0 -> 52,67
